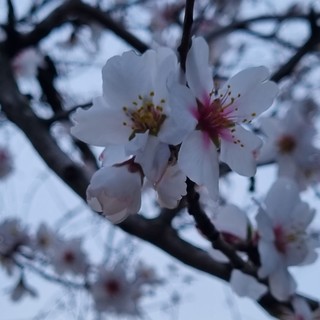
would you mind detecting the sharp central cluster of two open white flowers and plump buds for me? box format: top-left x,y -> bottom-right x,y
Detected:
71,38 -> 278,223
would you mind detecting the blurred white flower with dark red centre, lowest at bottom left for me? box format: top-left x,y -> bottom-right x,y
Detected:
89,266 -> 139,315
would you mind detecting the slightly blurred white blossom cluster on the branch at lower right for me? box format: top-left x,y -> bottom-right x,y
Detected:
211,178 -> 320,312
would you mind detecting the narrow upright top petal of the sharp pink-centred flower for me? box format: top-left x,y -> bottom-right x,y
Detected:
186,37 -> 213,101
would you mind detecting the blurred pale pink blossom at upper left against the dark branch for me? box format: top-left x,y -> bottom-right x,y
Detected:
12,47 -> 45,78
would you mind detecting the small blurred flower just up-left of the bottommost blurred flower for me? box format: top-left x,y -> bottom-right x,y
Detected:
52,238 -> 88,275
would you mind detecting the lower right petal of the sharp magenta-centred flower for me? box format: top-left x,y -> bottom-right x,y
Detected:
220,126 -> 262,177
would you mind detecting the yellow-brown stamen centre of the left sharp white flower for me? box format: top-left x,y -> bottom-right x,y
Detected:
122,91 -> 166,140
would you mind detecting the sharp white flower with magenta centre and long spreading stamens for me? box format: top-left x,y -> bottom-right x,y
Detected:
169,38 -> 278,199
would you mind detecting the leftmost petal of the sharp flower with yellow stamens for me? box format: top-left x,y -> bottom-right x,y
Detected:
71,97 -> 132,146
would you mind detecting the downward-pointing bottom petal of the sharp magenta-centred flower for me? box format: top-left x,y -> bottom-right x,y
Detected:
178,130 -> 219,200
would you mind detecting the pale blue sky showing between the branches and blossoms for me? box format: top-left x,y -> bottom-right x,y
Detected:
0,0 -> 320,320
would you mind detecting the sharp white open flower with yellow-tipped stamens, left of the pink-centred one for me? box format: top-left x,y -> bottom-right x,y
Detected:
71,48 -> 182,177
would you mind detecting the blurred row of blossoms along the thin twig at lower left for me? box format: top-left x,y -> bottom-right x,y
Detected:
0,218 -> 164,316
